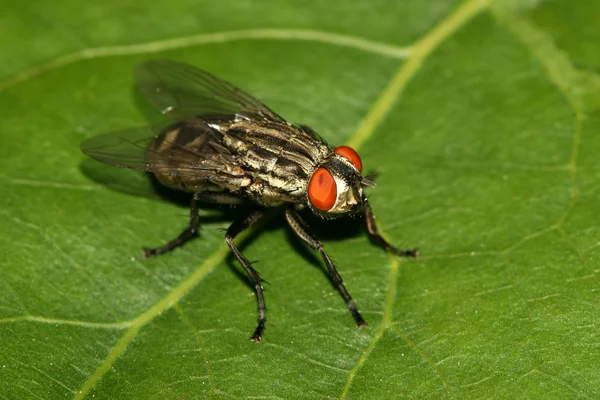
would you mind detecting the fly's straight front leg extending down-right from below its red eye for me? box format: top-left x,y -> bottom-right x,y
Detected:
285,207 -> 367,328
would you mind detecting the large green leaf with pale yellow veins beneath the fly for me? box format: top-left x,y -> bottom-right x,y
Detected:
0,0 -> 600,399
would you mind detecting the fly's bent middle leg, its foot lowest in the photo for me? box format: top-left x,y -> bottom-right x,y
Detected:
225,210 -> 267,342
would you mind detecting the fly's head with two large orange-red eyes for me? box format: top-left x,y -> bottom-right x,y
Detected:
306,146 -> 374,218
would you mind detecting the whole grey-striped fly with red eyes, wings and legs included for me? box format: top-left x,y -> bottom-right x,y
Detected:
81,60 -> 417,341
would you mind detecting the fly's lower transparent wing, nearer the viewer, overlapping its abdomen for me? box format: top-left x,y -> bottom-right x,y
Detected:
81,120 -> 244,180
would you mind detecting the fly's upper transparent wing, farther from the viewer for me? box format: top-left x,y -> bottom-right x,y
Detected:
134,60 -> 285,122
